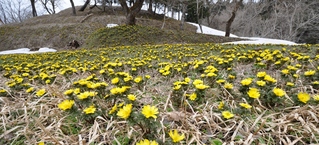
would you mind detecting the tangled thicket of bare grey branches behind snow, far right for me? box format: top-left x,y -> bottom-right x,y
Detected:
232,0 -> 319,42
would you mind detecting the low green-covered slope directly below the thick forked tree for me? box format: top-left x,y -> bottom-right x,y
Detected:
86,25 -> 237,48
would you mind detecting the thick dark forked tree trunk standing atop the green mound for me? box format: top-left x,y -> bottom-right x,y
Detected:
119,0 -> 144,25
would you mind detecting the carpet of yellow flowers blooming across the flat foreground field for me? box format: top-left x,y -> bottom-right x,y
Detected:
0,44 -> 319,144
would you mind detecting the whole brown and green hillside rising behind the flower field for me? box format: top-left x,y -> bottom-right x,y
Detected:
0,7 -> 242,51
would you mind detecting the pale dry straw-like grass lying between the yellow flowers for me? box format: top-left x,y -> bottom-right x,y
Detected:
0,44 -> 319,145
